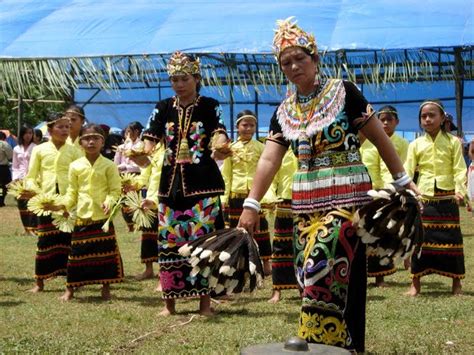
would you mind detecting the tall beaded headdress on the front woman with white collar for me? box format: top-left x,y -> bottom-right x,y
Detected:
273,16 -> 318,61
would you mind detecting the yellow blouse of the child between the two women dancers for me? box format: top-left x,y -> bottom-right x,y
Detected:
221,139 -> 276,204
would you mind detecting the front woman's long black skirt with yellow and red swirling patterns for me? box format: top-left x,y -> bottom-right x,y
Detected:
294,209 -> 367,352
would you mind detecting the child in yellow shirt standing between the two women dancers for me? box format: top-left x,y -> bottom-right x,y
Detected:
221,110 -> 276,275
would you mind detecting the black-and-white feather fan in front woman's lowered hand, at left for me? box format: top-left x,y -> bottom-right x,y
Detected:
179,228 -> 264,294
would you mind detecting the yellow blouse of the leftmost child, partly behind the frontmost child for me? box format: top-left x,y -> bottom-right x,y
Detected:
26,141 -> 81,195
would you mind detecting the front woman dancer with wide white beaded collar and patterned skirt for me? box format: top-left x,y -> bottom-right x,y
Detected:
240,18 -> 416,352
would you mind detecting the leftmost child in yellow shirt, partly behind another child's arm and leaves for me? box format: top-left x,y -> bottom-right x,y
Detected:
22,113 -> 81,292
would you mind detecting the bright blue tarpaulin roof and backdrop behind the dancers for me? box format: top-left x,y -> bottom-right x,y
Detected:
0,0 -> 474,131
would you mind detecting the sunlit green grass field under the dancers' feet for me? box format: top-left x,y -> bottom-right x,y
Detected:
0,199 -> 474,354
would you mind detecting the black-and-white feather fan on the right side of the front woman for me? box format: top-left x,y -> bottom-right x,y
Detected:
353,185 -> 423,265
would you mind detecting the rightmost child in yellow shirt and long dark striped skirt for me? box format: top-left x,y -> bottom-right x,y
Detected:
405,100 -> 467,296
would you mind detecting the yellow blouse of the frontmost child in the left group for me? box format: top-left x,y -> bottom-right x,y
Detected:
64,155 -> 121,221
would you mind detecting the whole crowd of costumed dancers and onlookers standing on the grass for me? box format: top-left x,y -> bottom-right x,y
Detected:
0,20 -> 474,352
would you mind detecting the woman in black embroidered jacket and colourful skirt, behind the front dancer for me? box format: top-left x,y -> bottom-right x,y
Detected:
143,52 -> 227,315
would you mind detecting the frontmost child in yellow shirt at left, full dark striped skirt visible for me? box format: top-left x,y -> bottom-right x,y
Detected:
57,124 -> 123,301
